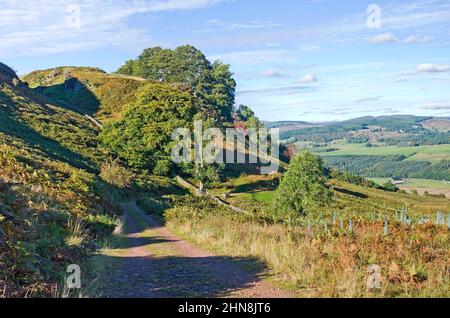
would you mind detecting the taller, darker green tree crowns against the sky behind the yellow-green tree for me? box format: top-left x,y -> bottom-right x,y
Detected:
117,45 -> 236,122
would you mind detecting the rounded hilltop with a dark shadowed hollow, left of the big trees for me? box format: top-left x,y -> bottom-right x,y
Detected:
22,67 -> 148,120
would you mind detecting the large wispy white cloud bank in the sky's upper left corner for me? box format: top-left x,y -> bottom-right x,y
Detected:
0,0 -> 227,58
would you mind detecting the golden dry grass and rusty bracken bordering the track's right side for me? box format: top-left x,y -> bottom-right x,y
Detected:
168,208 -> 450,297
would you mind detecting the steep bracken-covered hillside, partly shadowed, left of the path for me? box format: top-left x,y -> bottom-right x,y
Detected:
0,64 -> 118,297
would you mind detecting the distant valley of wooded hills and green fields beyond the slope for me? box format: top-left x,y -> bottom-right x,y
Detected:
270,115 -> 450,180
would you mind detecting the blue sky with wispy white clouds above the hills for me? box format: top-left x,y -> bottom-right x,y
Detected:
0,0 -> 450,122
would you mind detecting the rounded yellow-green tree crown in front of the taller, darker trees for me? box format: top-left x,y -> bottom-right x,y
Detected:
100,83 -> 203,175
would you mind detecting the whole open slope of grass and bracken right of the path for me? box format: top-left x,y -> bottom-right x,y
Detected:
156,176 -> 450,297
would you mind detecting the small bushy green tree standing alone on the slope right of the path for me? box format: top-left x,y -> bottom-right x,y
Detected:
274,151 -> 332,217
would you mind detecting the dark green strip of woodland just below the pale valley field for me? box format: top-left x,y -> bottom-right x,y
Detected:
325,155 -> 450,180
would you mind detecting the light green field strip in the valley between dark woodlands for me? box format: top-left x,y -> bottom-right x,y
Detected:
314,143 -> 450,162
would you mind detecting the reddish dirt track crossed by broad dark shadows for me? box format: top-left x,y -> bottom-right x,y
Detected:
97,202 -> 291,298
